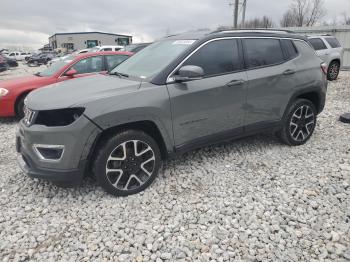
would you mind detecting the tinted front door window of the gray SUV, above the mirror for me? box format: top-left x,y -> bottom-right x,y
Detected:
183,39 -> 243,76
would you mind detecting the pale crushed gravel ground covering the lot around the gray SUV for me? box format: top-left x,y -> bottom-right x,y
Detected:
0,68 -> 350,261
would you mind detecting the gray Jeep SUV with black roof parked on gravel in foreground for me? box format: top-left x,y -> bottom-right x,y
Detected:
16,31 -> 327,196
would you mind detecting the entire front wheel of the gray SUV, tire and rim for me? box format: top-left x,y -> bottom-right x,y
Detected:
93,130 -> 161,196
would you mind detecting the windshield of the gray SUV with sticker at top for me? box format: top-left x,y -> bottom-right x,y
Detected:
111,40 -> 195,78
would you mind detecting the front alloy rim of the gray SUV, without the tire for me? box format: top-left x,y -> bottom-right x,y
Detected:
106,140 -> 155,191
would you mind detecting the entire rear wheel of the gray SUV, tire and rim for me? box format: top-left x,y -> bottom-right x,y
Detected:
277,99 -> 317,146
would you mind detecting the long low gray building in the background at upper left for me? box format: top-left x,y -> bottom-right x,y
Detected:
49,32 -> 132,51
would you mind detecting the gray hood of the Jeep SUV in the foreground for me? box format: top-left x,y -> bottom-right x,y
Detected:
26,74 -> 141,110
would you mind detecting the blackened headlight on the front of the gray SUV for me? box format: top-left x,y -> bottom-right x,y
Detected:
35,107 -> 85,126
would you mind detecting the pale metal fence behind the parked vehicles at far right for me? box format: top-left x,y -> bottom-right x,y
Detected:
283,25 -> 350,70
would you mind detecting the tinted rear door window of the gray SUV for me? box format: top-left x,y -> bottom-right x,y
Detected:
243,39 -> 284,68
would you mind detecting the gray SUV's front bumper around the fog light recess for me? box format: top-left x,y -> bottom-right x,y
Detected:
16,116 -> 101,185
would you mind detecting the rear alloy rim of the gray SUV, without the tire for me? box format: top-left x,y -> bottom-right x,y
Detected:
289,105 -> 316,142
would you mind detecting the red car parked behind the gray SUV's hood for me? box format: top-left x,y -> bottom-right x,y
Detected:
0,52 -> 132,118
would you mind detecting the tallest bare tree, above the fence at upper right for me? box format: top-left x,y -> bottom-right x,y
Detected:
280,0 -> 326,27
